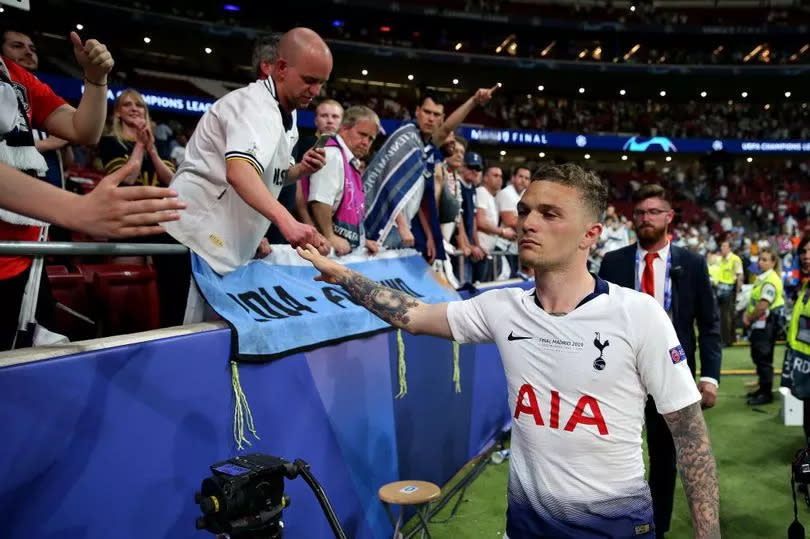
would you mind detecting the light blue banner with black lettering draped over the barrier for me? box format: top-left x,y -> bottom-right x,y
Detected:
192,245 -> 458,361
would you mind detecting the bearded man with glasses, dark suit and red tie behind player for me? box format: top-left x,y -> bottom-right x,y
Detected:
599,184 -> 722,538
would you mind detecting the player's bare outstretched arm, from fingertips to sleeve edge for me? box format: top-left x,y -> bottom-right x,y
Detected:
297,245 -> 453,339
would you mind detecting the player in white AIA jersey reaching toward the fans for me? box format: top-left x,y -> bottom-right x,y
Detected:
298,164 -> 720,539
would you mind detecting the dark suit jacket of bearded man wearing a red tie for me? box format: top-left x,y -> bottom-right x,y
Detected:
599,243 -> 722,381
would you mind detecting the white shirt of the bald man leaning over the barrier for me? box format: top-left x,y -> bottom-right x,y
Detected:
164,79 -> 298,274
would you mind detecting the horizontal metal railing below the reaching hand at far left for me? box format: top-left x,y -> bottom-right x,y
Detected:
0,241 -> 188,256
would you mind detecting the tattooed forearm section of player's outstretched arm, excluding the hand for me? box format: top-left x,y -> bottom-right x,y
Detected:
340,271 -> 420,329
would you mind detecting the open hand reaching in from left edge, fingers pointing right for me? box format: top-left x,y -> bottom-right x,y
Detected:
67,170 -> 186,238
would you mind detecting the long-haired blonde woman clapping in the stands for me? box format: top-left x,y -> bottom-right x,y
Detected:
98,88 -> 175,186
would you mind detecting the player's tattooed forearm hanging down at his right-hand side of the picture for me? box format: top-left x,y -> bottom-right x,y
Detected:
664,403 -> 720,539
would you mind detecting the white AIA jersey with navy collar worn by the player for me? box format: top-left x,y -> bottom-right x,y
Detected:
447,279 -> 700,539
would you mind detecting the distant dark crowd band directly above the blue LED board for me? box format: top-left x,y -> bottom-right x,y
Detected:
326,84 -> 810,140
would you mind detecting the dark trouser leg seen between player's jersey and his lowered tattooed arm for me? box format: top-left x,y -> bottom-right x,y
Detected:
644,397 -> 677,537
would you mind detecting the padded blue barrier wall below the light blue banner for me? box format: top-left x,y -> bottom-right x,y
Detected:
0,284 -> 510,539
